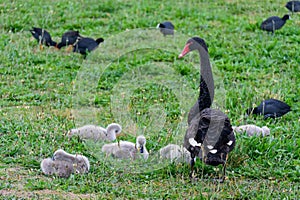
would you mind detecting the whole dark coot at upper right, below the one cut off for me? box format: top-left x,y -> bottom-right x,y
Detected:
260,15 -> 290,33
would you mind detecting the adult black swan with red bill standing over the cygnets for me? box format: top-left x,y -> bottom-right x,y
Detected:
179,37 -> 235,182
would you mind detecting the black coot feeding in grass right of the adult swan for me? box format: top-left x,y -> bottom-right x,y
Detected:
246,99 -> 291,119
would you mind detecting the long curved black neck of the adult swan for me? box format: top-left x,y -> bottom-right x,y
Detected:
198,47 -> 214,111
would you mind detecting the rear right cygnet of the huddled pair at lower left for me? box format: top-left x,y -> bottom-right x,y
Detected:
52,149 -> 90,174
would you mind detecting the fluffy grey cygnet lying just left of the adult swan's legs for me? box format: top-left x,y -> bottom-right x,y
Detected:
159,144 -> 191,163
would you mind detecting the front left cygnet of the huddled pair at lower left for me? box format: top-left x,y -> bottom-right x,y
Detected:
41,158 -> 74,178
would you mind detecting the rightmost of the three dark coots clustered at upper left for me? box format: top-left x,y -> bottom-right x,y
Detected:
73,38 -> 104,56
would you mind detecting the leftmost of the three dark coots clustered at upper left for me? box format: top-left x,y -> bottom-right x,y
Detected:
30,27 -> 57,49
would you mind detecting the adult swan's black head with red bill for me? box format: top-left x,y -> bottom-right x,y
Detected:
178,37 -> 208,58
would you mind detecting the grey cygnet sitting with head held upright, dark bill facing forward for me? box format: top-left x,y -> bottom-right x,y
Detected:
102,135 -> 149,160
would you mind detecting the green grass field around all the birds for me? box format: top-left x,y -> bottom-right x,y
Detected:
0,0 -> 300,199
